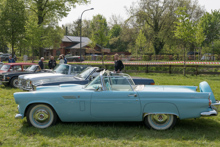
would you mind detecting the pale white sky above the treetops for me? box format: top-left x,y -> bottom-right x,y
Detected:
59,0 -> 220,26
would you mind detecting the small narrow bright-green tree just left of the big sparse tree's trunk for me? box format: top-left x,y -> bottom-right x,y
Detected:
135,30 -> 147,56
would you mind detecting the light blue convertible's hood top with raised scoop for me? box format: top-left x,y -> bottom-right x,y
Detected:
36,84 -> 85,92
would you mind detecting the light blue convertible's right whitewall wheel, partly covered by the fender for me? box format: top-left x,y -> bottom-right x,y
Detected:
144,114 -> 177,130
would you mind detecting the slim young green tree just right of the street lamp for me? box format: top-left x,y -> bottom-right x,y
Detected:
91,14 -> 109,66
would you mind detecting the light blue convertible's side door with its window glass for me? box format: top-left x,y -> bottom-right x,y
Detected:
91,77 -> 141,121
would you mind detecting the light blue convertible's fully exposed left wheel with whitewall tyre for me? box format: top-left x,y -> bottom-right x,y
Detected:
26,104 -> 57,129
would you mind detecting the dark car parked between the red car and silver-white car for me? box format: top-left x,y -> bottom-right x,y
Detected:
0,64 -> 52,88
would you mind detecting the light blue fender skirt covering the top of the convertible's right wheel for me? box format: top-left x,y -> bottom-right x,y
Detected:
143,103 -> 180,117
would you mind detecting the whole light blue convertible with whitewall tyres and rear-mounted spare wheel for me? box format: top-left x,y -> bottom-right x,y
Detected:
14,71 -> 220,130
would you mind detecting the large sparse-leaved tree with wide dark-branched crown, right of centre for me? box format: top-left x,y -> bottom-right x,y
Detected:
128,0 -> 203,54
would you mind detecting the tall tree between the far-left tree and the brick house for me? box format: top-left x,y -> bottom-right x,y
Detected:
26,0 -> 88,56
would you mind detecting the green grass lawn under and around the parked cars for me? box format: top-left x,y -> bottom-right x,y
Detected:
0,73 -> 220,147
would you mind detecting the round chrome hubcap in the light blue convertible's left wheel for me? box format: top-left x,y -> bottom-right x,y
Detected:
34,109 -> 49,123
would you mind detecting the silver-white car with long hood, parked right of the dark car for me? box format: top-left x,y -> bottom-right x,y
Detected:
18,64 -> 88,90
